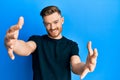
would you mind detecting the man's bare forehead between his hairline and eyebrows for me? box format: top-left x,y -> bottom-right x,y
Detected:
43,12 -> 61,23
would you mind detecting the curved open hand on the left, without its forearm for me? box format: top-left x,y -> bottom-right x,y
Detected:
4,17 -> 24,60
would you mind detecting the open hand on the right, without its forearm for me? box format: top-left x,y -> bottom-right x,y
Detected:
81,41 -> 98,79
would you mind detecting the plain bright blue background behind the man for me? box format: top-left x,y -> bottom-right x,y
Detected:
0,0 -> 120,80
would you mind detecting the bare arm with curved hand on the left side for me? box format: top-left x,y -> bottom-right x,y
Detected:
4,17 -> 36,59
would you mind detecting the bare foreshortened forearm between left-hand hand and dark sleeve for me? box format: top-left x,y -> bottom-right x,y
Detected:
13,40 -> 33,56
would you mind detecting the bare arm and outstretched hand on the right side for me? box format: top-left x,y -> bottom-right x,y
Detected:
71,42 -> 98,78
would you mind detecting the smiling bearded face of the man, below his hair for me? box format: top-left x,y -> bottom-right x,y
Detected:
43,12 -> 64,39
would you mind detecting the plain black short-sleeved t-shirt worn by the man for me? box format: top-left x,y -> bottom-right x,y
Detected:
29,35 -> 79,80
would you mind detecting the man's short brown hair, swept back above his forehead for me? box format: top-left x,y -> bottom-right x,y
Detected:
40,6 -> 61,18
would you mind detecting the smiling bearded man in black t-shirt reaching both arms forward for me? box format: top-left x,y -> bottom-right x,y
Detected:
5,6 -> 98,80
